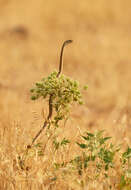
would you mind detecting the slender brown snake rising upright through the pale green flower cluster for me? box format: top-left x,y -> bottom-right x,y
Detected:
31,40 -> 72,146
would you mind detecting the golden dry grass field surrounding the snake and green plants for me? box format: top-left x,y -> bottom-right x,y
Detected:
0,0 -> 131,190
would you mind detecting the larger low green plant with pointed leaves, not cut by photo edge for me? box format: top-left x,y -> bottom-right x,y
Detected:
71,131 -> 119,178
